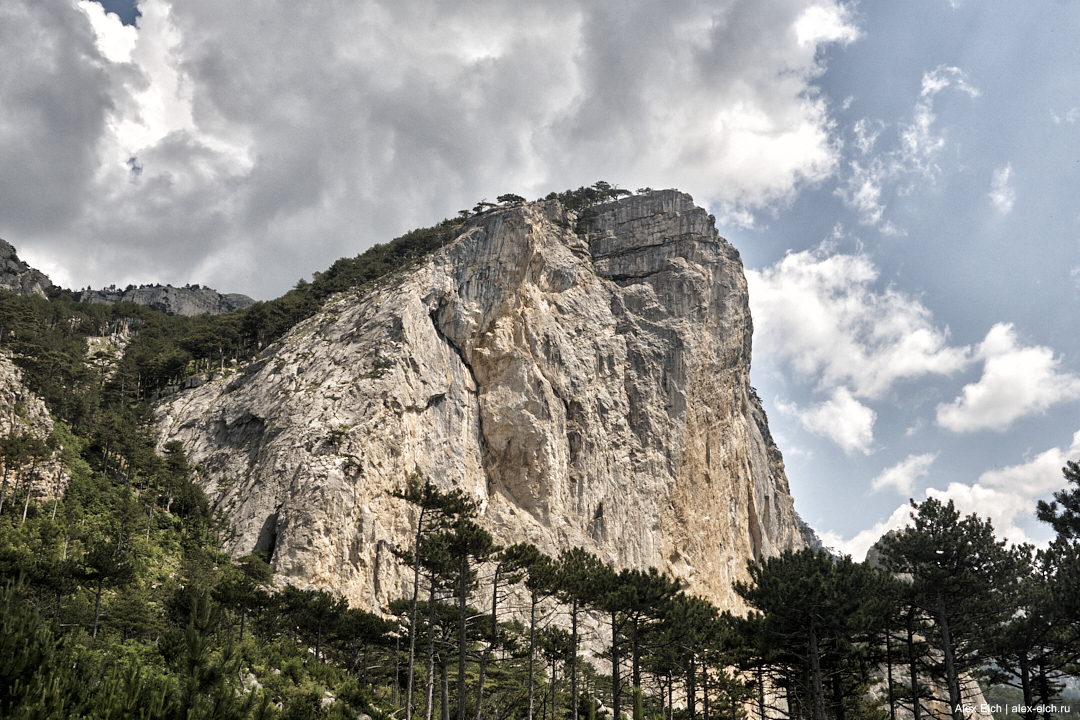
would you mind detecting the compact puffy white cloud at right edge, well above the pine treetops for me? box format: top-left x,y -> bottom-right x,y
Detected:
937,323 -> 1080,433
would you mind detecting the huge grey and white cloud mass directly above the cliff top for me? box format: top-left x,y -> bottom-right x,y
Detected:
0,0 -> 858,297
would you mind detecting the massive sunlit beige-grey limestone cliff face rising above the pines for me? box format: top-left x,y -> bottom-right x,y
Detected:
158,191 -> 804,608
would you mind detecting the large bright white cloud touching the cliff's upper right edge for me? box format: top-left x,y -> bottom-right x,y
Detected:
746,247 -> 969,398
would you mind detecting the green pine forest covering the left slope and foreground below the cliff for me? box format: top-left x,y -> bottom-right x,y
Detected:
0,194 -> 1080,720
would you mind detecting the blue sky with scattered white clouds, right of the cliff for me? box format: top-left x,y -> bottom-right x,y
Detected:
728,2 -> 1080,555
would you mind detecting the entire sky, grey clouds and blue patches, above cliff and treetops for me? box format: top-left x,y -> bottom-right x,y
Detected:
0,0 -> 1080,559
